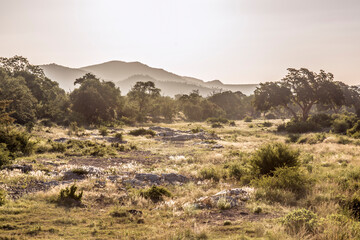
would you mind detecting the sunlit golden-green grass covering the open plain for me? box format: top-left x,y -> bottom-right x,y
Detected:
0,120 -> 360,239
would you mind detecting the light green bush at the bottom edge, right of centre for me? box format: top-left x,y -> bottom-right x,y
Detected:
282,208 -> 318,234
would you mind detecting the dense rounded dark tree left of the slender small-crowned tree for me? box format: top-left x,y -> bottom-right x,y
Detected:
70,74 -> 122,124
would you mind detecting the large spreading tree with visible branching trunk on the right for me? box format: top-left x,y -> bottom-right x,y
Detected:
254,68 -> 344,121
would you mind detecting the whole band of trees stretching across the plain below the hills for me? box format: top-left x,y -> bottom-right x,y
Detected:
0,56 -> 360,126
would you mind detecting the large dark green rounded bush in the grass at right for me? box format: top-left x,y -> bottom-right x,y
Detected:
250,143 -> 300,175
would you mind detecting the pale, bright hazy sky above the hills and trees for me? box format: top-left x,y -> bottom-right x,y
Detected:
0,0 -> 360,84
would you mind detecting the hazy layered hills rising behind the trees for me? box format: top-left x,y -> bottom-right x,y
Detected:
40,61 -> 257,97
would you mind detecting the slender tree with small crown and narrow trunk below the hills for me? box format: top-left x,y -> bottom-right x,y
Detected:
127,81 -> 161,121
